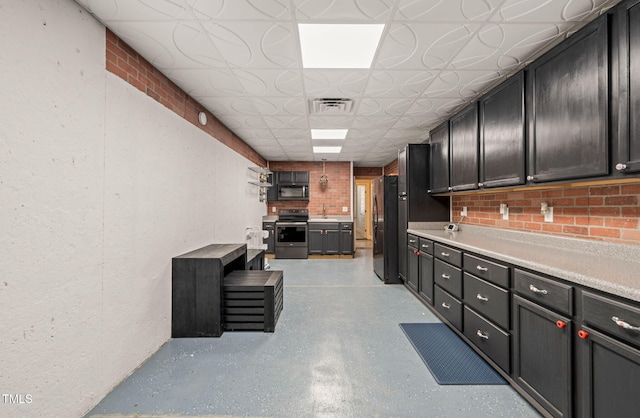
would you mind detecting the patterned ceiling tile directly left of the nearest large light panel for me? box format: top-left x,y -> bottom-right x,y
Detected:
202,21 -> 299,69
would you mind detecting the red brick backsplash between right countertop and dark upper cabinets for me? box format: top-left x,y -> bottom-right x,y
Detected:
452,182 -> 640,245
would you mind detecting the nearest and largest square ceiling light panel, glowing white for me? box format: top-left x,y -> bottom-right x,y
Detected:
298,23 -> 384,68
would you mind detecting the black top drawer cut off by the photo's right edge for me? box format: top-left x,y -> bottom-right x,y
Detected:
582,292 -> 640,347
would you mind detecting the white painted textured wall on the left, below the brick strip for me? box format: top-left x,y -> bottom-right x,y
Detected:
0,0 -> 265,417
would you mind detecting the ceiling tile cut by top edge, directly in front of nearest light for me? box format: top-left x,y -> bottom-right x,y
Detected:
293,0 -> 396,23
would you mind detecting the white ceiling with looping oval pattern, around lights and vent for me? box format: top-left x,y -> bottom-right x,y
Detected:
76,0 -> 619,166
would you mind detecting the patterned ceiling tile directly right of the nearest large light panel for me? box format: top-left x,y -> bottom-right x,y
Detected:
374,23 -> 480,70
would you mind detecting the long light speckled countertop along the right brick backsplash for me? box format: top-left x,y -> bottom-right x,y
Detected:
408,223 -> 640,302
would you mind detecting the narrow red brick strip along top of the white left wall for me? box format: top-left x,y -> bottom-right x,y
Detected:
106,29 -> 266,167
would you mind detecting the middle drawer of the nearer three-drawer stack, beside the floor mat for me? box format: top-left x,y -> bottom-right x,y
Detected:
464,273 -> 509,330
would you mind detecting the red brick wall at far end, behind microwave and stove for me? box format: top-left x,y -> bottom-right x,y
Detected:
267,161 -> 352,217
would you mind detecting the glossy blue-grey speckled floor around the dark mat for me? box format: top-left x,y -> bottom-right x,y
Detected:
87,249 -> 539,417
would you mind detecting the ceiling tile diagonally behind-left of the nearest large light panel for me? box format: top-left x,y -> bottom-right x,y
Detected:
233,69 -> 304,97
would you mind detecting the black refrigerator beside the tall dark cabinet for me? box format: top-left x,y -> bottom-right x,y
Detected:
373,176 -> 402,284
